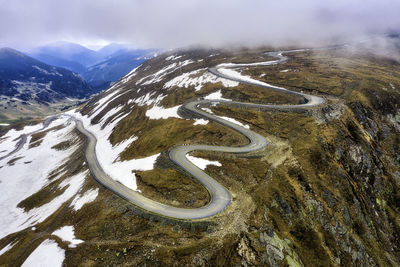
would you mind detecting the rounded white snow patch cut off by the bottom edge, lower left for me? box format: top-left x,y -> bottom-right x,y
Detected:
21,239 -> 65,267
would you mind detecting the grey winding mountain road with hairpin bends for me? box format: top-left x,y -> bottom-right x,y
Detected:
3,50 -> 324,220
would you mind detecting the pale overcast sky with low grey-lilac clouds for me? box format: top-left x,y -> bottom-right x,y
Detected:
0,0 -> 400,48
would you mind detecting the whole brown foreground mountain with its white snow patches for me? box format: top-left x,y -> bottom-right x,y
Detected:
0,45 -> 400,266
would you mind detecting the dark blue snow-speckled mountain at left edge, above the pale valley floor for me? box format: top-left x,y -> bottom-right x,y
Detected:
0,48 -> 95,102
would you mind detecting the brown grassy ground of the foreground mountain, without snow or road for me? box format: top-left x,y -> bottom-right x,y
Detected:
0,47 -> 400,266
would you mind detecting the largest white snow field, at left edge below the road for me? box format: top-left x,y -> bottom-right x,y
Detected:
0,118 -> 87,239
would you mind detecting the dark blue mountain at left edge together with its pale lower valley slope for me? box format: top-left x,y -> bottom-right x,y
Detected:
0,48 -> 95,122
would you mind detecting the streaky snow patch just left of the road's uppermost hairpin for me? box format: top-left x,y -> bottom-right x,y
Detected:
163,69 -> 239,91
